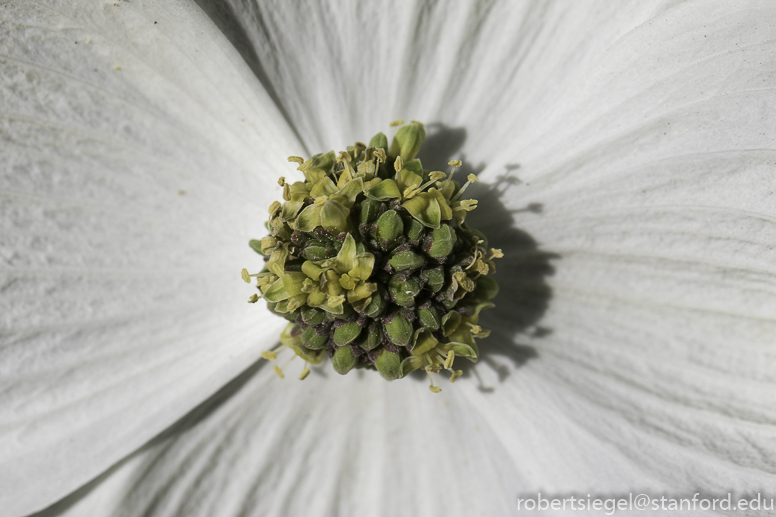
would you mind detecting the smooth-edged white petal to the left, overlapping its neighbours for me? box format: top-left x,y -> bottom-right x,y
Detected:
0,1 -> 300,515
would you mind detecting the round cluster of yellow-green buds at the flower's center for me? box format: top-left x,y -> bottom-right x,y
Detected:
242,121 -> 502,392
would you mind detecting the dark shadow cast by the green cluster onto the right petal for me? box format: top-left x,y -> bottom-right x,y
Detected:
418,124 -> 560,391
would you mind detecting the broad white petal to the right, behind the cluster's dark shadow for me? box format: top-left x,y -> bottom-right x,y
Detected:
472,2 -> 776,494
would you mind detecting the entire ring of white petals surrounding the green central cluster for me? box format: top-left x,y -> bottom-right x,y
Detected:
0,0 -> 776,516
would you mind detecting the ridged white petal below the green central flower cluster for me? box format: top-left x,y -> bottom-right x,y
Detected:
31,362 -> 528,517
